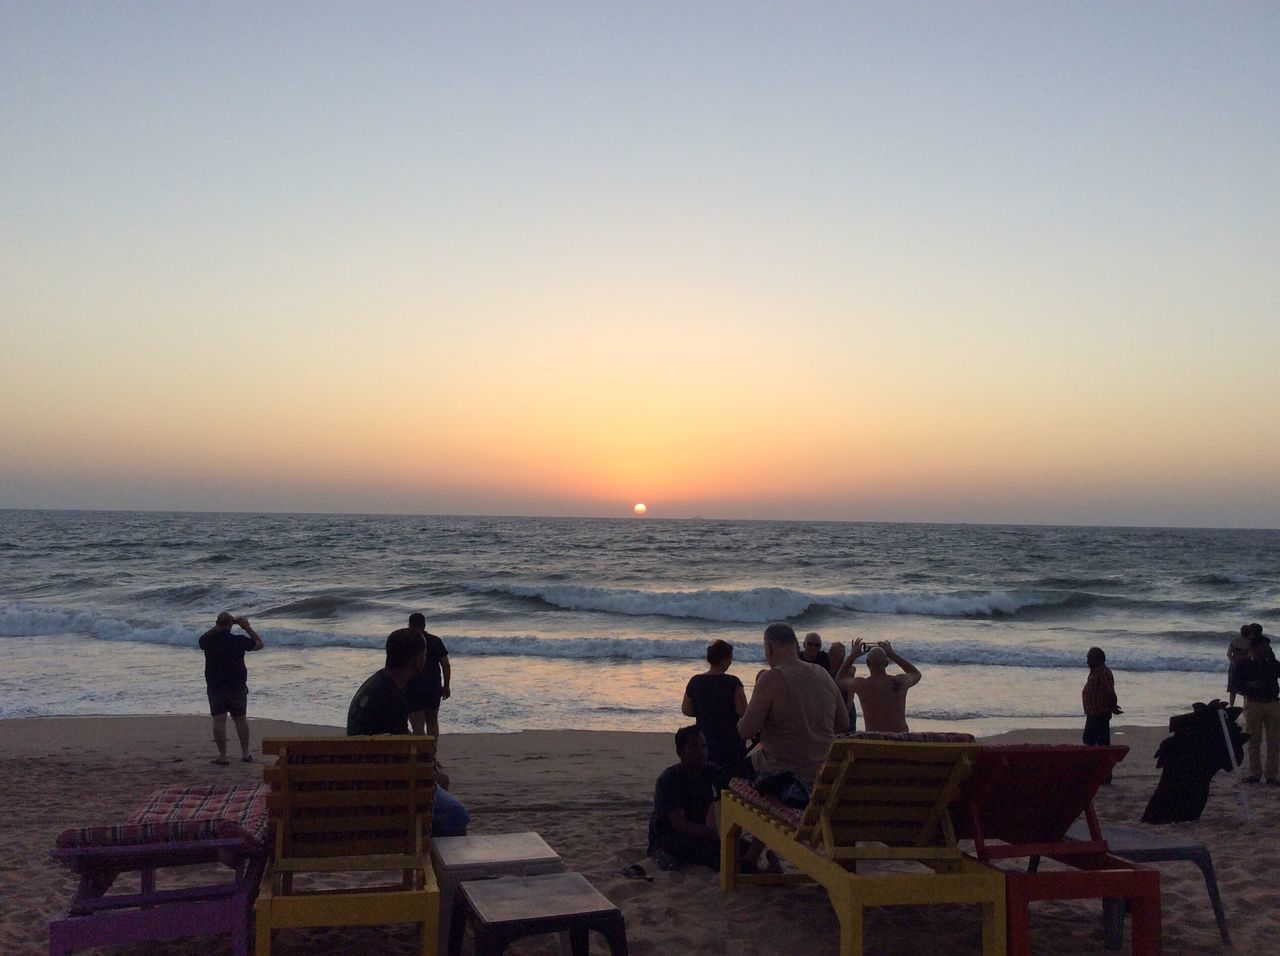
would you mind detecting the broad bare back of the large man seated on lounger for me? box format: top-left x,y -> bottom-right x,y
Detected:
760,660 -> 844,785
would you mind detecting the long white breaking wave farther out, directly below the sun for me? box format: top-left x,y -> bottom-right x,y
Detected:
470,582 -> 1111,625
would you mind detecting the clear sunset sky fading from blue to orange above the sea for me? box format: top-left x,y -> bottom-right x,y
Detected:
0,1 -> 1280,527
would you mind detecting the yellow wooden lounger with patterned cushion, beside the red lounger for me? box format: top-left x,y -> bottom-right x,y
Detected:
721,735 -> 1005,956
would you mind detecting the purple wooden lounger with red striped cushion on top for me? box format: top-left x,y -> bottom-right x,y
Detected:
49,783 -> 268,956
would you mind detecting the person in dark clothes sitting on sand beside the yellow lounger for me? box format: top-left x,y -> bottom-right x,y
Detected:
649,727 -> 719,870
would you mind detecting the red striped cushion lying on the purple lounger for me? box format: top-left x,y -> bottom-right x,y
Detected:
55,783 -> 269,850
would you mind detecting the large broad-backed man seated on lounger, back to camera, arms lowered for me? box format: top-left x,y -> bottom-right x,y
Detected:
737,623 -> 849,786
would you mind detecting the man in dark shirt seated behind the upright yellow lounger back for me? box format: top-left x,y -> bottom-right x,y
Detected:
347,627 -> 471,837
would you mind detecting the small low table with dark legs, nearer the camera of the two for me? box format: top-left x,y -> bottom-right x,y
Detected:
449,873 -> 627,956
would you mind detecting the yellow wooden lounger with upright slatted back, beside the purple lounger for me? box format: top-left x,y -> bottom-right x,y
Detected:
256,736 -> 440,956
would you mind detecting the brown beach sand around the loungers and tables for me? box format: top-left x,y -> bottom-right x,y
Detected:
0,717 -> 1280,956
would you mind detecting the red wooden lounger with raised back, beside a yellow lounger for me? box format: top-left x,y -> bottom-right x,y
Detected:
951,745 -> 1161,956
